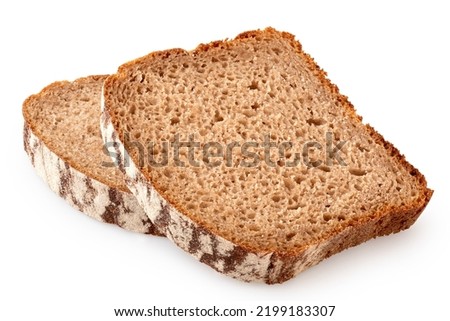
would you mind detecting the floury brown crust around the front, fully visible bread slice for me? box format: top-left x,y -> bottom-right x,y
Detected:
101,28 -> 433,284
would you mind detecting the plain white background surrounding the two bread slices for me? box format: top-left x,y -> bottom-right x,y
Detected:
0,0 -> 450,320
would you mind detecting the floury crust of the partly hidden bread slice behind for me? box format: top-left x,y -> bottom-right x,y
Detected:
23,76 -> 161,235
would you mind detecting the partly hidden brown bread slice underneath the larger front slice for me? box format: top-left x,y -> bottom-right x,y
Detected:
23,76 -> 160,235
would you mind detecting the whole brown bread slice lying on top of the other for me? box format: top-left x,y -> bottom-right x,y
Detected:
102,28 -> 432,283
